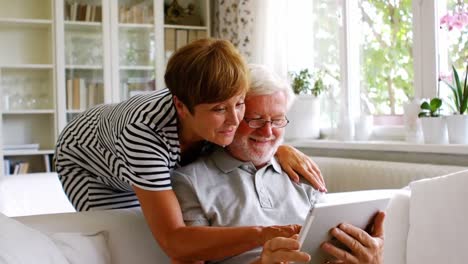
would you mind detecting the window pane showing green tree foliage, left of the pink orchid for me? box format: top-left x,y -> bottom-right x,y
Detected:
358,0 -> 414,115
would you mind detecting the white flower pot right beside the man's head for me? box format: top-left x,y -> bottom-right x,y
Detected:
284,95 -> 320,139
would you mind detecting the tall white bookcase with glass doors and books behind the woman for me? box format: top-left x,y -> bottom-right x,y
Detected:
0,0 -> 210,176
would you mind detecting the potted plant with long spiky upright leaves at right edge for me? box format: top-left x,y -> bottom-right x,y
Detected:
443,64 -> 468,144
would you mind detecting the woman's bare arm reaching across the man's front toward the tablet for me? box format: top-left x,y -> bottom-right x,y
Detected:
133,186 -> 300,261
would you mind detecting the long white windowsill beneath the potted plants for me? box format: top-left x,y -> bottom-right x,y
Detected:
285,139 -> 468,155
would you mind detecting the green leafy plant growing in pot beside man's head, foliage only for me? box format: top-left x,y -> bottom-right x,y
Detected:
290,69 -> 327,96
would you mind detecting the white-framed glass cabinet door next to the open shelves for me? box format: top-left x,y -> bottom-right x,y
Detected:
55,0 -> 110,128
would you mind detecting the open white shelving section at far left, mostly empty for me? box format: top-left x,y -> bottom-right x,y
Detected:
0,0 -> 57,175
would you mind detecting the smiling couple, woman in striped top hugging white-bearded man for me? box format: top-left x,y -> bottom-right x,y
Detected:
54,39 -> 384,264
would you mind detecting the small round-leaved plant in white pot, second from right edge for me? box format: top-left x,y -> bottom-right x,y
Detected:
418,97 -> 448,144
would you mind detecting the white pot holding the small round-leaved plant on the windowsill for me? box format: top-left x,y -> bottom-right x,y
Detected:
421,117 -> 448,144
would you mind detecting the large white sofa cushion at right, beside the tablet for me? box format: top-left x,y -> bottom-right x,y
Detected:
407,170 -> 468,264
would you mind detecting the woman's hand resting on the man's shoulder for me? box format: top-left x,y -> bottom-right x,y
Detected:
276,145 -> 327,192
